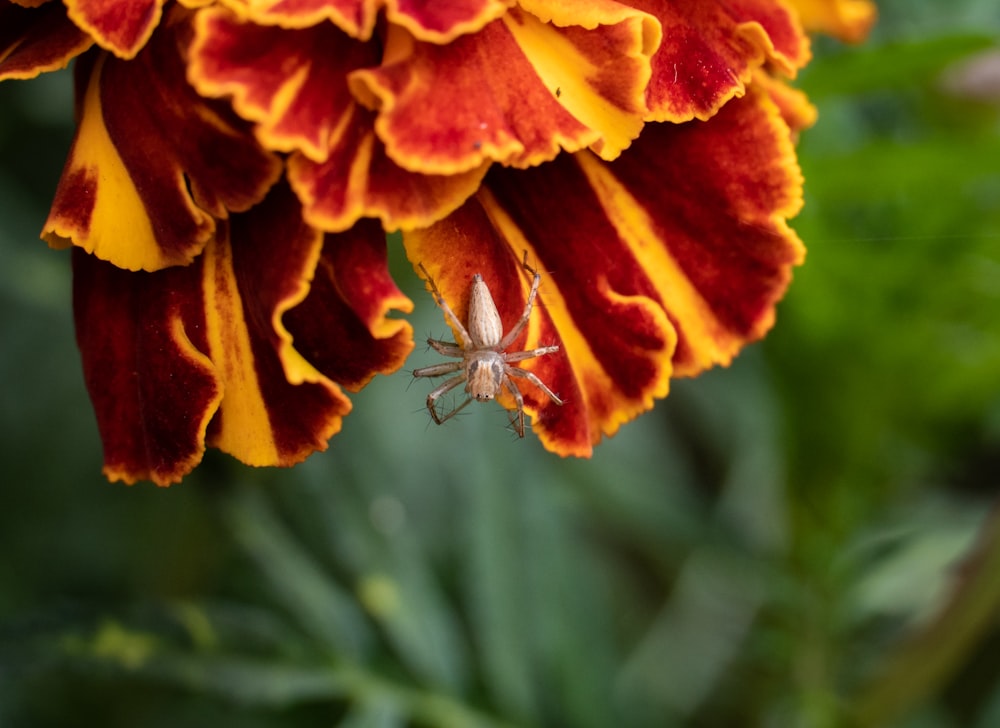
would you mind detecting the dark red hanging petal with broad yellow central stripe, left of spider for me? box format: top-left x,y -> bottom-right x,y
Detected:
202,186 -> 351,466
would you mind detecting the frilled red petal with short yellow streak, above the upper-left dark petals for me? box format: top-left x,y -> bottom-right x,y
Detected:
188,8 -> 379,162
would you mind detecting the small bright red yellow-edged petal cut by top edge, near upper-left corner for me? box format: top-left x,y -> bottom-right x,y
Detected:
65,0 -> 166,59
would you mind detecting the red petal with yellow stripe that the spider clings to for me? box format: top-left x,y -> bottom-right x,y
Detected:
404,193 -> 676,457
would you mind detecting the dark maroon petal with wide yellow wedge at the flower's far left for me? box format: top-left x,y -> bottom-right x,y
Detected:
42,13 -> 281,271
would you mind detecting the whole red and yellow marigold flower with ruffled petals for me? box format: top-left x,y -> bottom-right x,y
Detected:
0,0 -> 874,485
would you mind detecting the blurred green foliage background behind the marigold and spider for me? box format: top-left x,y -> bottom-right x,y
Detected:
0,0 -> 1000,728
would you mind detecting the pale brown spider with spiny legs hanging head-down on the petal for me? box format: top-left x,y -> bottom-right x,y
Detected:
413,252 -> 563,437
